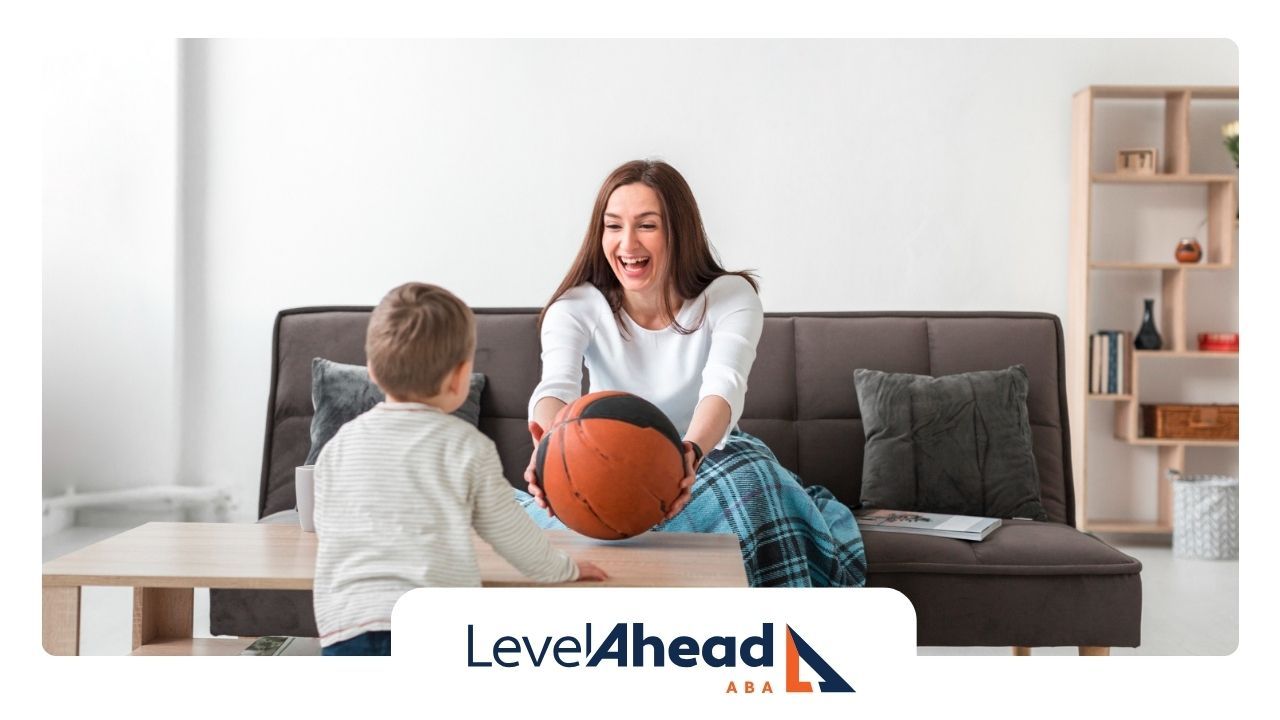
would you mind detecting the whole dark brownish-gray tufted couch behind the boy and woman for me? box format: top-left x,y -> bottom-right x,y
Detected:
210,307 -> 1142,647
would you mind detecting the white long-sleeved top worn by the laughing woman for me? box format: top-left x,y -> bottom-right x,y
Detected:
529,275 -> 764,452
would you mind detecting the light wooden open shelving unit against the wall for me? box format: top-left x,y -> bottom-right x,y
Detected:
1066,86 -> 1240,534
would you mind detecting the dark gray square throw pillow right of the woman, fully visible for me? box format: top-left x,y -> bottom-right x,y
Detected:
854,365 -> 1047,520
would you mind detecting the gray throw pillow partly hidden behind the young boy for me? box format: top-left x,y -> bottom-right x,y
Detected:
306,357 -> 485,465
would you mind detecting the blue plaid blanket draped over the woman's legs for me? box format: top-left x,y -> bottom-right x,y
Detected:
515,430 -> 867,588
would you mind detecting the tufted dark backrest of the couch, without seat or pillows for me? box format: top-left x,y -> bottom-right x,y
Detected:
259,307 -> 1075,525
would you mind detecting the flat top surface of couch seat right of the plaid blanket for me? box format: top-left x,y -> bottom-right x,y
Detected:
863,520 -> 1142,575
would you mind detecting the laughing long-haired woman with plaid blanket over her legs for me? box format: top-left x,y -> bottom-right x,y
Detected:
521,160 -> 867,587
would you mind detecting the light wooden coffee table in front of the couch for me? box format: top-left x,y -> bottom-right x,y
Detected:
42,523 -> 746,655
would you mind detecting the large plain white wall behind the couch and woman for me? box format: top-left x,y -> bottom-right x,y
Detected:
46,41 -> 1238,516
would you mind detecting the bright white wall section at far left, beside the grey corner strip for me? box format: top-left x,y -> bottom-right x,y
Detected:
42,41 -> 179,496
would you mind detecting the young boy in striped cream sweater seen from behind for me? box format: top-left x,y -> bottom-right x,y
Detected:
315,283 -> 607,655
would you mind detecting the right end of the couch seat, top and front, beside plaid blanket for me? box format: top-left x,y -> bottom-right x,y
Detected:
863,520 -> 1142,647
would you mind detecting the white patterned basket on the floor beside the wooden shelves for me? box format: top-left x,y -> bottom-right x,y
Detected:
1169,470 -> 1240,560
